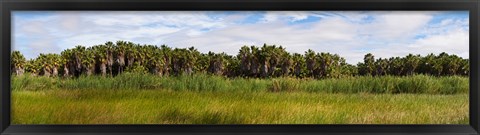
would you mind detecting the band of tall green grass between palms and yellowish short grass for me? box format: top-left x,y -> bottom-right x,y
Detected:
12,73 -> 469,94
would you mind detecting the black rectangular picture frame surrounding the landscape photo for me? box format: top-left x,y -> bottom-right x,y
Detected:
0,0 -> 480,135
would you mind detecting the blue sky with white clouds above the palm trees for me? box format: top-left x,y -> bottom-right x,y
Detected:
12,11 -> 469,64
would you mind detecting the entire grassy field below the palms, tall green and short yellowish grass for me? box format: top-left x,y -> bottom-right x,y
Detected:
12,74 -> 469,124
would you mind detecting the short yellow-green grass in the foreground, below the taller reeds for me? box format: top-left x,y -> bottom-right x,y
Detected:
12,89 -> 468,124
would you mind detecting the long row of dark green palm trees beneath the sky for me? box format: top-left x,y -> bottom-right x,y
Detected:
11,41 -> 470,79
